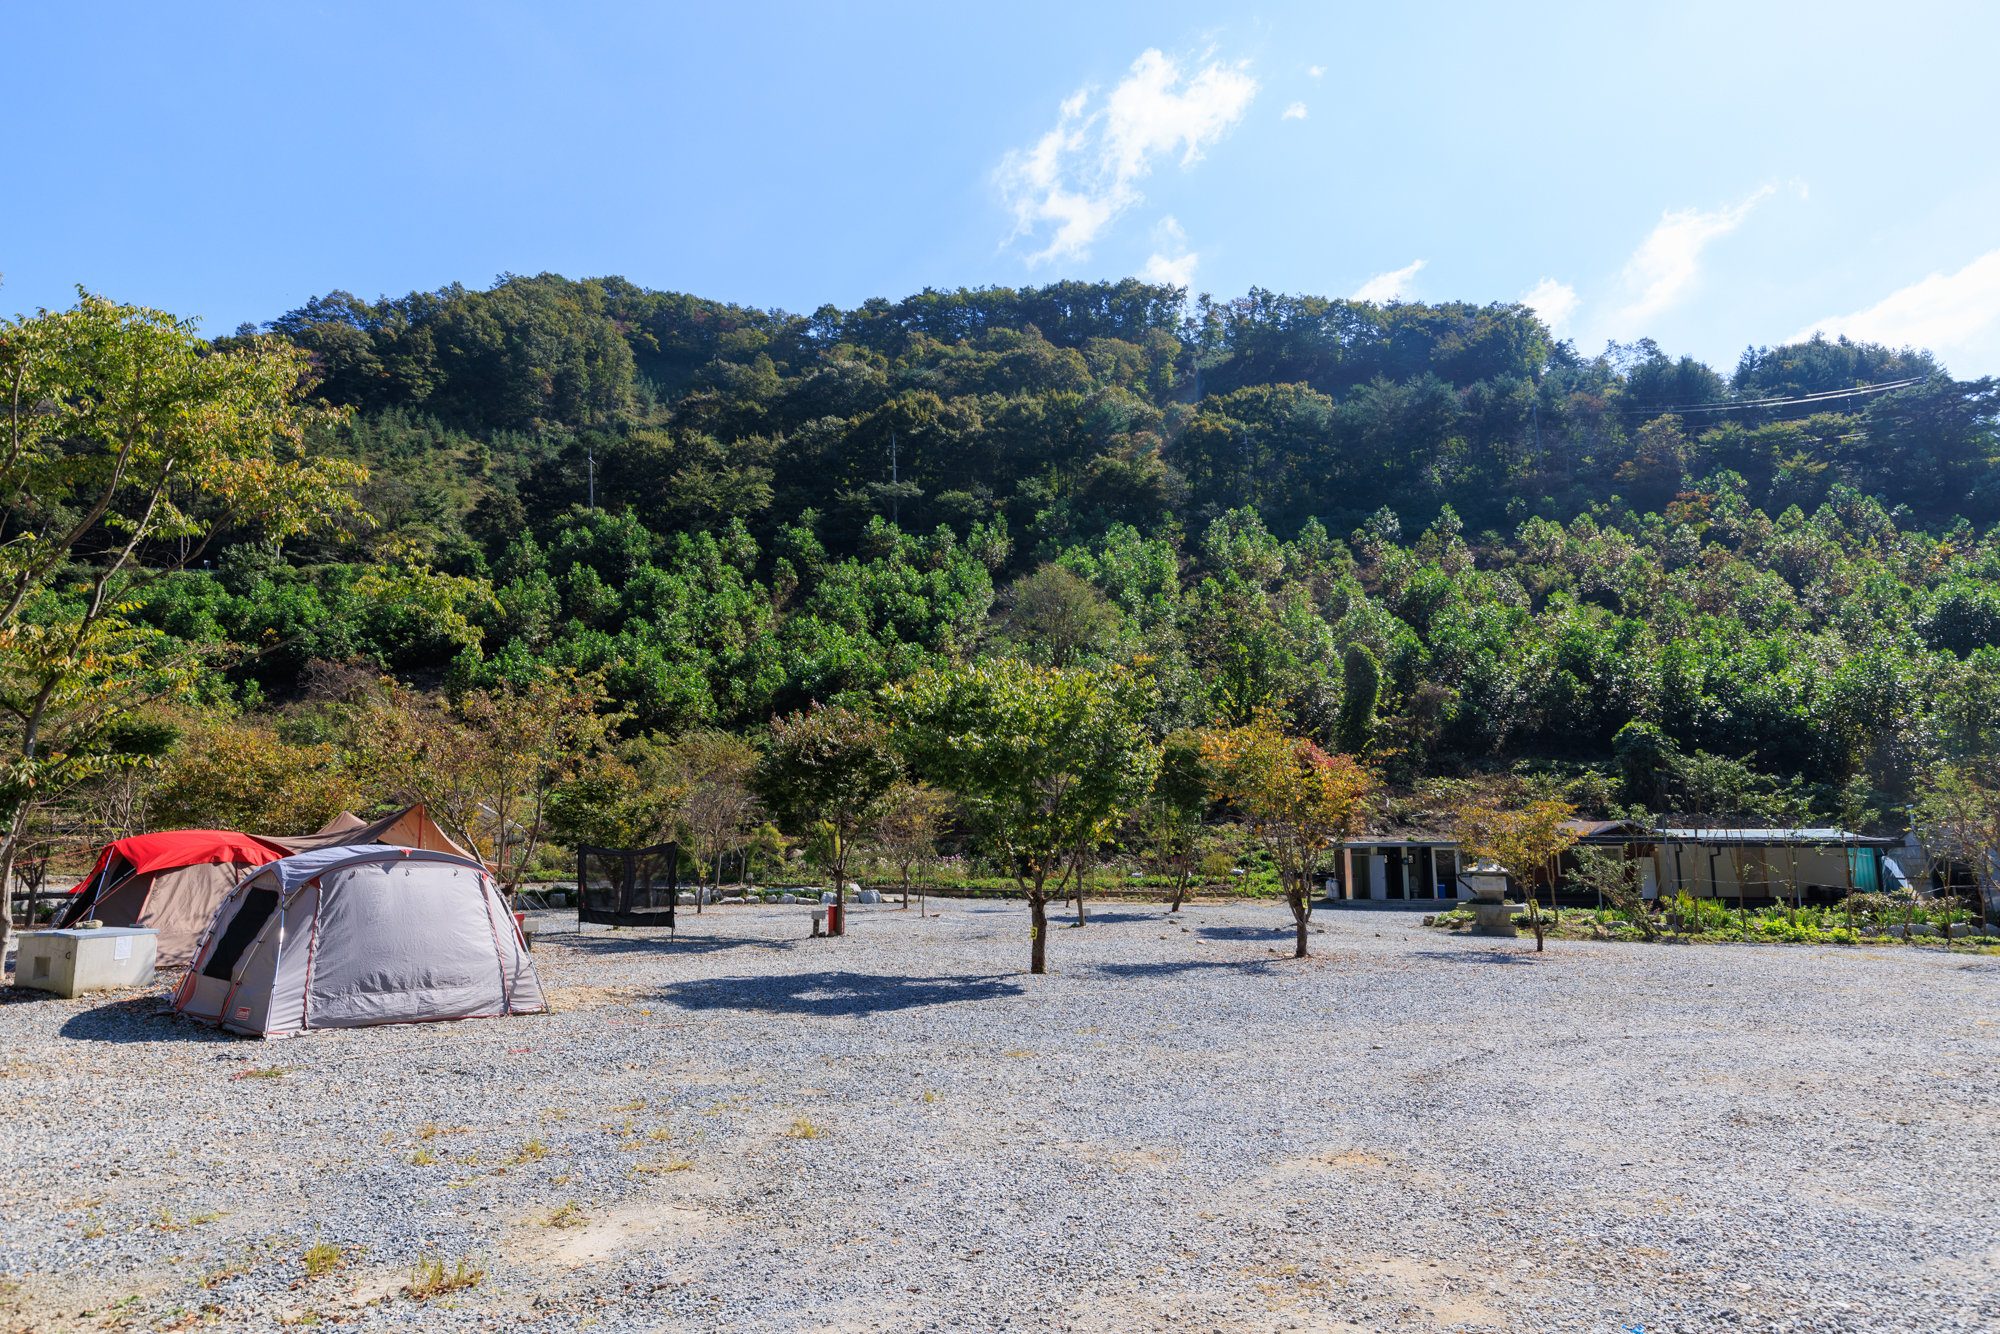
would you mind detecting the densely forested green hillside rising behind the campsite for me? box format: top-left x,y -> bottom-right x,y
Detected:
144,274 -> 2000,824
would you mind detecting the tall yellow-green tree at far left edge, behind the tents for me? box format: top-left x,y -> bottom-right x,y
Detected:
0,292 -> 364,942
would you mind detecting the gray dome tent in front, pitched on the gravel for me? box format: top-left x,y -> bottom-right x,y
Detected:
174,844 -> 548,1038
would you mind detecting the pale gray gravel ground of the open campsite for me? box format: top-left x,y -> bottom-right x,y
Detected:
0,902 -> 2000,1332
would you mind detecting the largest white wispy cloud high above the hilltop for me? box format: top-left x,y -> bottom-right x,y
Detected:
994,50 -> 1256,264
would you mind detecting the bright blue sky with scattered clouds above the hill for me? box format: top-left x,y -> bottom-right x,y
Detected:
0,0 -> 2000,376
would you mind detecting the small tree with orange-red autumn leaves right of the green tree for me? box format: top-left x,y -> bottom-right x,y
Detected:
1202,708 -> 1374,958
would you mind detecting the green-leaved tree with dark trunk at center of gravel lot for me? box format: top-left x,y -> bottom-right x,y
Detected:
886,662 -> 1160,974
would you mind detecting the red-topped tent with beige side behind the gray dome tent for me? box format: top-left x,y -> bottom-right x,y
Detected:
56,830 -> 290,968
